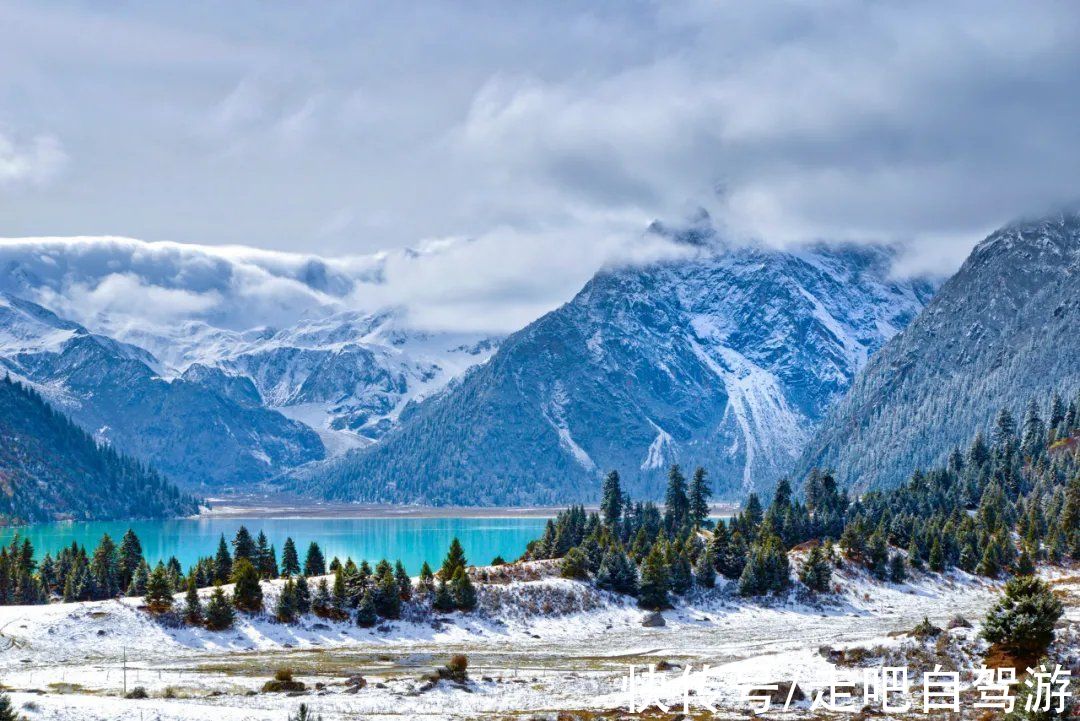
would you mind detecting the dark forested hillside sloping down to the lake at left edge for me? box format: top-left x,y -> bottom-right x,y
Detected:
0,376 -> 198,525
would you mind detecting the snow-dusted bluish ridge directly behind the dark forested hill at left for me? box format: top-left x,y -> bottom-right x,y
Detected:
0,294 -> 325,486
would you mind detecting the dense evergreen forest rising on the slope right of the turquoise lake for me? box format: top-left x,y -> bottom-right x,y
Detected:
528,388 -> 1080,609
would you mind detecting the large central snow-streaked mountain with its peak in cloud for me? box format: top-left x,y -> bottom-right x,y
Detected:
295,233 -> 932,504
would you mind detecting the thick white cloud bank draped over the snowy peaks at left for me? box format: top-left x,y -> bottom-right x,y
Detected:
0,229 -> 685,342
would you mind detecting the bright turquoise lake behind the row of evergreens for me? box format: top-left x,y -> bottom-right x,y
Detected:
0,517 -> 546,575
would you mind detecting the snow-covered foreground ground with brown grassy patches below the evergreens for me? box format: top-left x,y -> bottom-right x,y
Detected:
0,562 -> 1080,721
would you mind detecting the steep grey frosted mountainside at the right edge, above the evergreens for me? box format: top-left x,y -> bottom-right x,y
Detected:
800,210 -> 1080,487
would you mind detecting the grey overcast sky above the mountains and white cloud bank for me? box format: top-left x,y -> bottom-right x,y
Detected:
0,0 -> 1080,319
